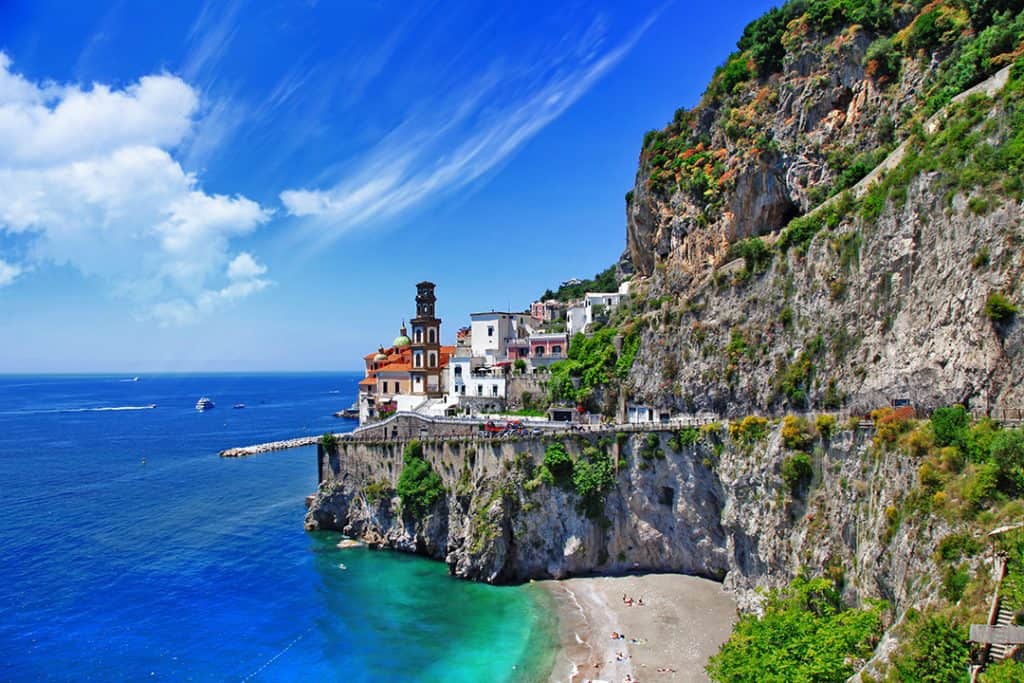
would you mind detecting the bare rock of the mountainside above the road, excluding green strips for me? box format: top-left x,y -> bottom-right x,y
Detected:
621,9 -> 1024,416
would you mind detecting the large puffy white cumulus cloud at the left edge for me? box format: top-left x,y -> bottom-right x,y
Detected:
0,53 -> 270,322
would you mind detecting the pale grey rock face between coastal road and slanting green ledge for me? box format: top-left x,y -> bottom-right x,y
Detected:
631,178 -> 1024,416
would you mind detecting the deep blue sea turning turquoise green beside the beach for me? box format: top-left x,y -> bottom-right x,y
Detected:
0,374 -> 554,681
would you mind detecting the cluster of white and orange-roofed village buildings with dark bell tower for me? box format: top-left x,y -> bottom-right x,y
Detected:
357,282 -> 628,424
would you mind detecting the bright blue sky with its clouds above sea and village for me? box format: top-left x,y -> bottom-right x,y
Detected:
0,0 -> 772,373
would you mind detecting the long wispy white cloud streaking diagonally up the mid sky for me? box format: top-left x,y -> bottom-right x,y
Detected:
281,12 -> 656,244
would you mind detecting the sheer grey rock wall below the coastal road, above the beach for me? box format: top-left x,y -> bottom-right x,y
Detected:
306,429 -> 948,611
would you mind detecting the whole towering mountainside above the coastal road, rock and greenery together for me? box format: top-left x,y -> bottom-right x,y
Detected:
622,1 -> 1024,415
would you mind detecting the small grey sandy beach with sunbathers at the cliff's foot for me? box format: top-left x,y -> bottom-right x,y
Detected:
541,573 -> 736,683
